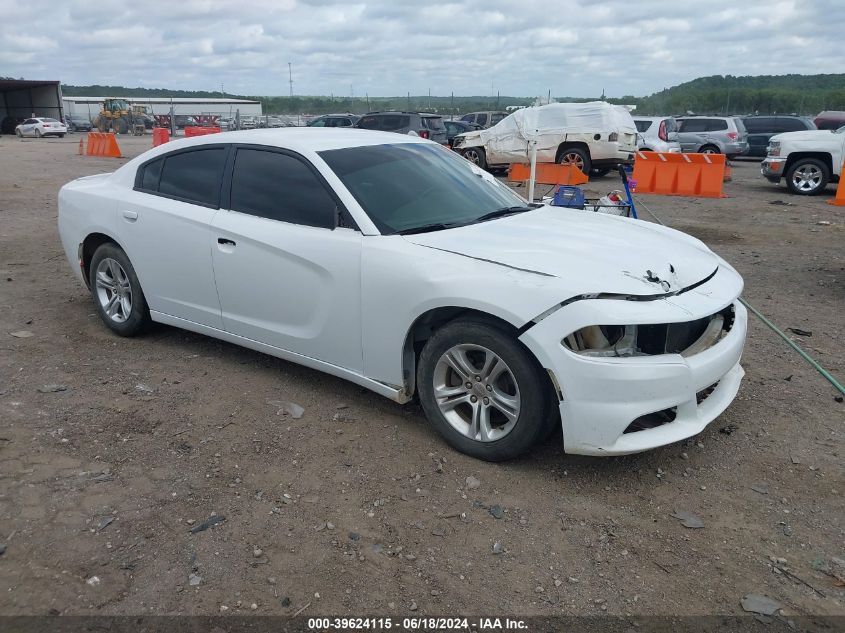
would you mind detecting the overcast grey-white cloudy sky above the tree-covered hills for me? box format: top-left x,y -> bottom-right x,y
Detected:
0,0 -> 845,97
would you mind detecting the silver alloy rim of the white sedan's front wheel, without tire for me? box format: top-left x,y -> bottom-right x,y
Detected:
433,344 -> 520,442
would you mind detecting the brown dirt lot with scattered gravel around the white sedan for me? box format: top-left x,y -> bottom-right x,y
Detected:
0,135 -> 845,616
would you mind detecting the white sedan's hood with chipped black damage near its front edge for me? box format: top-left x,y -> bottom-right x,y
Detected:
405,206 -> 720,298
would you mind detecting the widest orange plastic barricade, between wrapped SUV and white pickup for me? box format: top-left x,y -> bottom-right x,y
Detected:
631,152 -> 725,198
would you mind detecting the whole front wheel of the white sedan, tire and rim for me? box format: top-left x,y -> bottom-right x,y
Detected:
417,319 -> 556,462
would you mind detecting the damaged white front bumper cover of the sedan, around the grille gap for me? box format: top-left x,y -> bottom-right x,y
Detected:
520,267 -> 747,455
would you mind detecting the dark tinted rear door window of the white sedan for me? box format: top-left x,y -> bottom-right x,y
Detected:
158,147 -> 226,206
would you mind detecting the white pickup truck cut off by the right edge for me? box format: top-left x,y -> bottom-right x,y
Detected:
760,126 -> 845,196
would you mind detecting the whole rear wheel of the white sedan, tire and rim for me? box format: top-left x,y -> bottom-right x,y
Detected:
88,242 -> 152,336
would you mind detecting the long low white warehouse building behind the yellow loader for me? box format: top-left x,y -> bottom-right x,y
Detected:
63,95 -> 262,119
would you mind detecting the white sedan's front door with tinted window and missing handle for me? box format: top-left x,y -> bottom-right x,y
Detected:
210,145 -> 363,372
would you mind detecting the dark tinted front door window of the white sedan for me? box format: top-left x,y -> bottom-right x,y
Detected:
230,149 -> 337,228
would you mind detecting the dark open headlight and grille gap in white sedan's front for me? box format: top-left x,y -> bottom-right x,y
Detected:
561,305 -> 734,358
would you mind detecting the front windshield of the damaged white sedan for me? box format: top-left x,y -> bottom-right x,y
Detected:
320,143 -> 526,233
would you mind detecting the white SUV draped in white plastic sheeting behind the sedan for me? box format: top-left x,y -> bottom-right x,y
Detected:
453,101 -> 637,175
